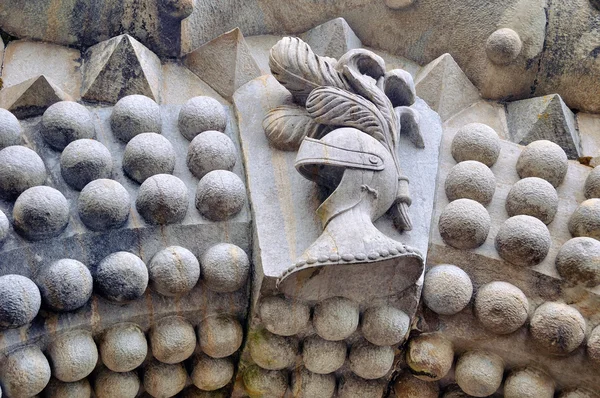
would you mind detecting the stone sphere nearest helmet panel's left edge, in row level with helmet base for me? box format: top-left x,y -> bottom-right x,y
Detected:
200,243 -> 250,293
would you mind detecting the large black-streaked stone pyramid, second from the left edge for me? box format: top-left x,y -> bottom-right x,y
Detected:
81,35 -> 161,103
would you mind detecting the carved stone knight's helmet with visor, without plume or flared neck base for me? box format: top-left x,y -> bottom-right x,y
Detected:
296,127 -> 398,227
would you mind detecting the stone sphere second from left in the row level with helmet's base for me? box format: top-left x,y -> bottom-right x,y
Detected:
38,258 -> 94,311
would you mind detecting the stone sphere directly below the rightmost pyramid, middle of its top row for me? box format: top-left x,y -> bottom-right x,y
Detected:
517,140 -> 569,188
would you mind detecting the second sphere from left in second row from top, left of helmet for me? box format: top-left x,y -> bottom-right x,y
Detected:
60,139 -> 113,191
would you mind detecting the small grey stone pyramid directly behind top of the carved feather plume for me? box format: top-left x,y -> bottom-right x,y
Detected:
302,18 -> 362,58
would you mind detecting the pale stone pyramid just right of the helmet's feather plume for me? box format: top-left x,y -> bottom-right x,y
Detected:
415,54 -> 480,121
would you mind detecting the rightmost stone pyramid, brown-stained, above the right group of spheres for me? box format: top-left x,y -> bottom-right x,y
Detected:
507,94 -> 582,159
